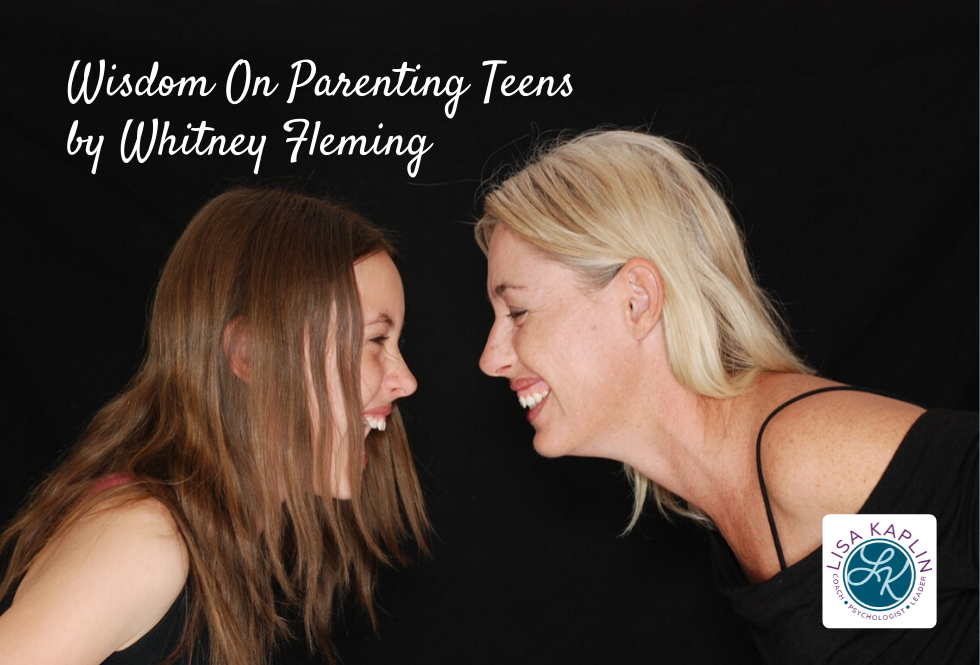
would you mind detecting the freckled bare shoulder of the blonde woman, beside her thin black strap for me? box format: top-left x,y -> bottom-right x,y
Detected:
762,382 -> 923,558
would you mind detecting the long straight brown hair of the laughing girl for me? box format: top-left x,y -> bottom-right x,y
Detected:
0,189 -> 428,664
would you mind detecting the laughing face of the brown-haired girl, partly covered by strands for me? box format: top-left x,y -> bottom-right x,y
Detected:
328,252 -> 418,499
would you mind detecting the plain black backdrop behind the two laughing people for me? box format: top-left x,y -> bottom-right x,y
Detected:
0,1 -> 978,664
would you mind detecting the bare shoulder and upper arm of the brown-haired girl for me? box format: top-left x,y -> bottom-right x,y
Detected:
0,498 -> 188,664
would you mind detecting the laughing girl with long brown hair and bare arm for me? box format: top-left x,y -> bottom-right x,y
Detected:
0,189 -> 427,665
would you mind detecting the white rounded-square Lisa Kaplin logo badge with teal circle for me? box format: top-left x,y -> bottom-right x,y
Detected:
822,515 -> 937,628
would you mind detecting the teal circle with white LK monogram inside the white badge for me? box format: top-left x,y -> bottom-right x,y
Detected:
844,538 -> 915,612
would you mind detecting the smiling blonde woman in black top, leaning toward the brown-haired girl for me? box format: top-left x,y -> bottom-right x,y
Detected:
476,131 -> 978,662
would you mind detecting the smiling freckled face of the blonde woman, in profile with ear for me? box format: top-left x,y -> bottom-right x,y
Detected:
480,224 -> 632,457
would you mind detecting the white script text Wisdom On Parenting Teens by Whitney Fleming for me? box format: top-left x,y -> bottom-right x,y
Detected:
68,59 -> 572,178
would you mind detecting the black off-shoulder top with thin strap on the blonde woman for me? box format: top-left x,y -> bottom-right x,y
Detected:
706,386 -> 980,663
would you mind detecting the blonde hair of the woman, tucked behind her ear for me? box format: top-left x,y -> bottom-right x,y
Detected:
476,130 -> 811,529
